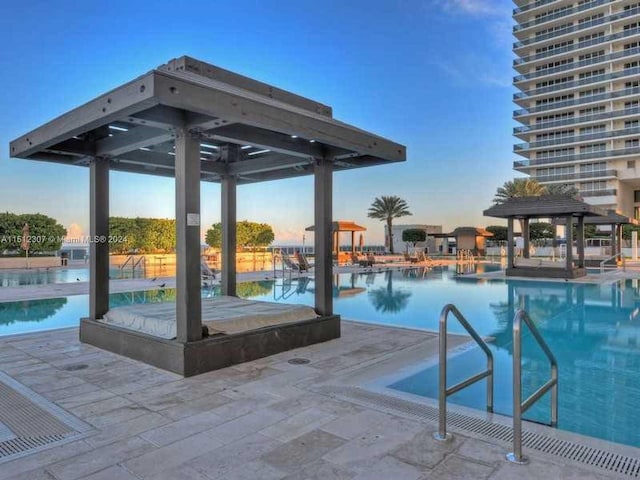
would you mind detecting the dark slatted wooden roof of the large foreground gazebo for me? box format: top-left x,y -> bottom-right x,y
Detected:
10,57 -> 406,183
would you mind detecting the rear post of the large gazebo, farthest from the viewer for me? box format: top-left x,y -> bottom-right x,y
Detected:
220,176 -> 238,297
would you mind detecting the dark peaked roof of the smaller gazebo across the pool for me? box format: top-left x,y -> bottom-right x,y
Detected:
483,195 -> 606,218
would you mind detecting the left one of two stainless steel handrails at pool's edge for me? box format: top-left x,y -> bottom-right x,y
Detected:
433,303 -> 493,442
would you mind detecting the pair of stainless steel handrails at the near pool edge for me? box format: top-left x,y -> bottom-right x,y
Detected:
433,304 -> 558,465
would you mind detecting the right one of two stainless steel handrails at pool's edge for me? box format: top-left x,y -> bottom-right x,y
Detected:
507,310 -> 558,464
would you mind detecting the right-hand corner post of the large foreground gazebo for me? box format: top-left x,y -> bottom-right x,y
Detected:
313,158 -> 333,316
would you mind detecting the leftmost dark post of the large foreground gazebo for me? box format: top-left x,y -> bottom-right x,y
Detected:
89,158 -> 109,320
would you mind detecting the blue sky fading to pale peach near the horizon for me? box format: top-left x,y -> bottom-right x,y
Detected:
0,0 -> 516,244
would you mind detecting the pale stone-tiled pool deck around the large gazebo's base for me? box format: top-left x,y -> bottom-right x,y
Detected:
0,322 -> 628,480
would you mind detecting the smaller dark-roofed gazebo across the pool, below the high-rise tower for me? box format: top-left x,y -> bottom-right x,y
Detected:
483,195 -> 606,278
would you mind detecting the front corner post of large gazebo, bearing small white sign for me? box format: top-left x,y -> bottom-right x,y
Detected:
175,127 -> 202,343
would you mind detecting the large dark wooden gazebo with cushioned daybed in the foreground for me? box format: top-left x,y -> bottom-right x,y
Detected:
10,57 -> 406,376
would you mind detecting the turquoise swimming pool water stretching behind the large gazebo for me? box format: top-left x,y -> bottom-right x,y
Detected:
0,266 -> 640,446
